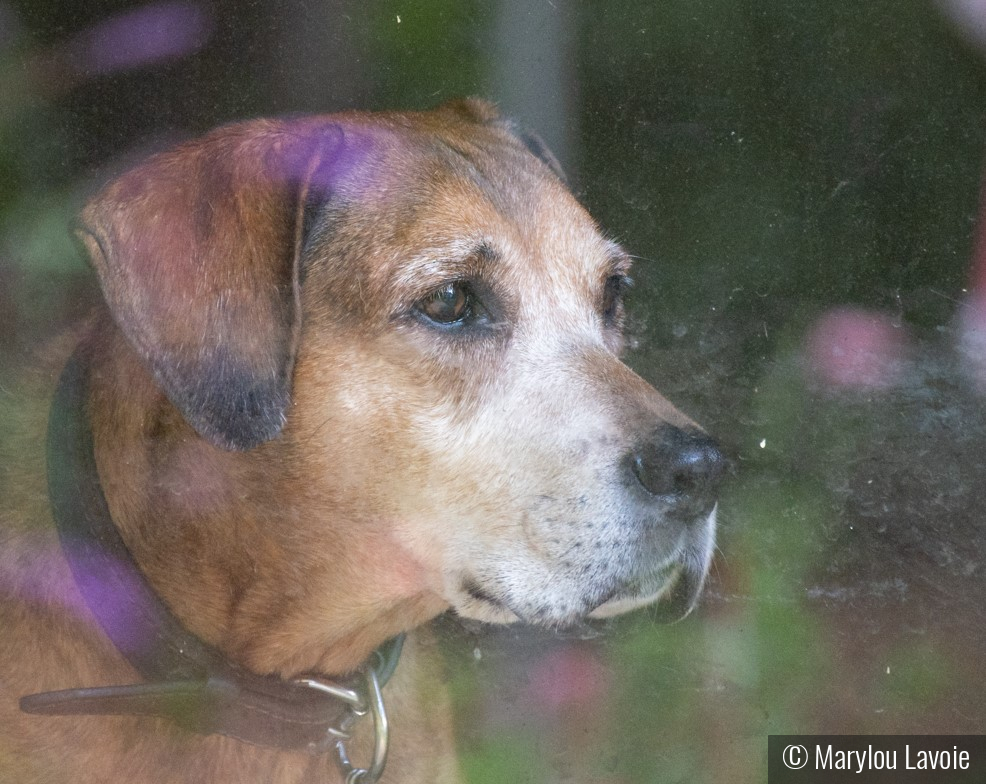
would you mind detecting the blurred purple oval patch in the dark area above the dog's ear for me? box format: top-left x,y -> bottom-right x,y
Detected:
68,1 -> 213,74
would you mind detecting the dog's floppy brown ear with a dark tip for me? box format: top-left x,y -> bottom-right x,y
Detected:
78,121 -> 343,449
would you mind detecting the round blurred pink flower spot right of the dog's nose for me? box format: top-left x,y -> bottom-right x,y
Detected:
806,307 -> 908,389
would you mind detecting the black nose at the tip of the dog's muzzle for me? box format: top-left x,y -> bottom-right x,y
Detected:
628,425 -> 726,517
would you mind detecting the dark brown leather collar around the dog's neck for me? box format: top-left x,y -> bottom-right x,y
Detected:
20,347 -> 404,754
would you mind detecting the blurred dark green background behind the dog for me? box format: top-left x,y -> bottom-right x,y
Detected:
0,0 -> 986,784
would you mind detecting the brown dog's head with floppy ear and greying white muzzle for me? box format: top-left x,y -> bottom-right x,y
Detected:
80,101 -> 722,672
